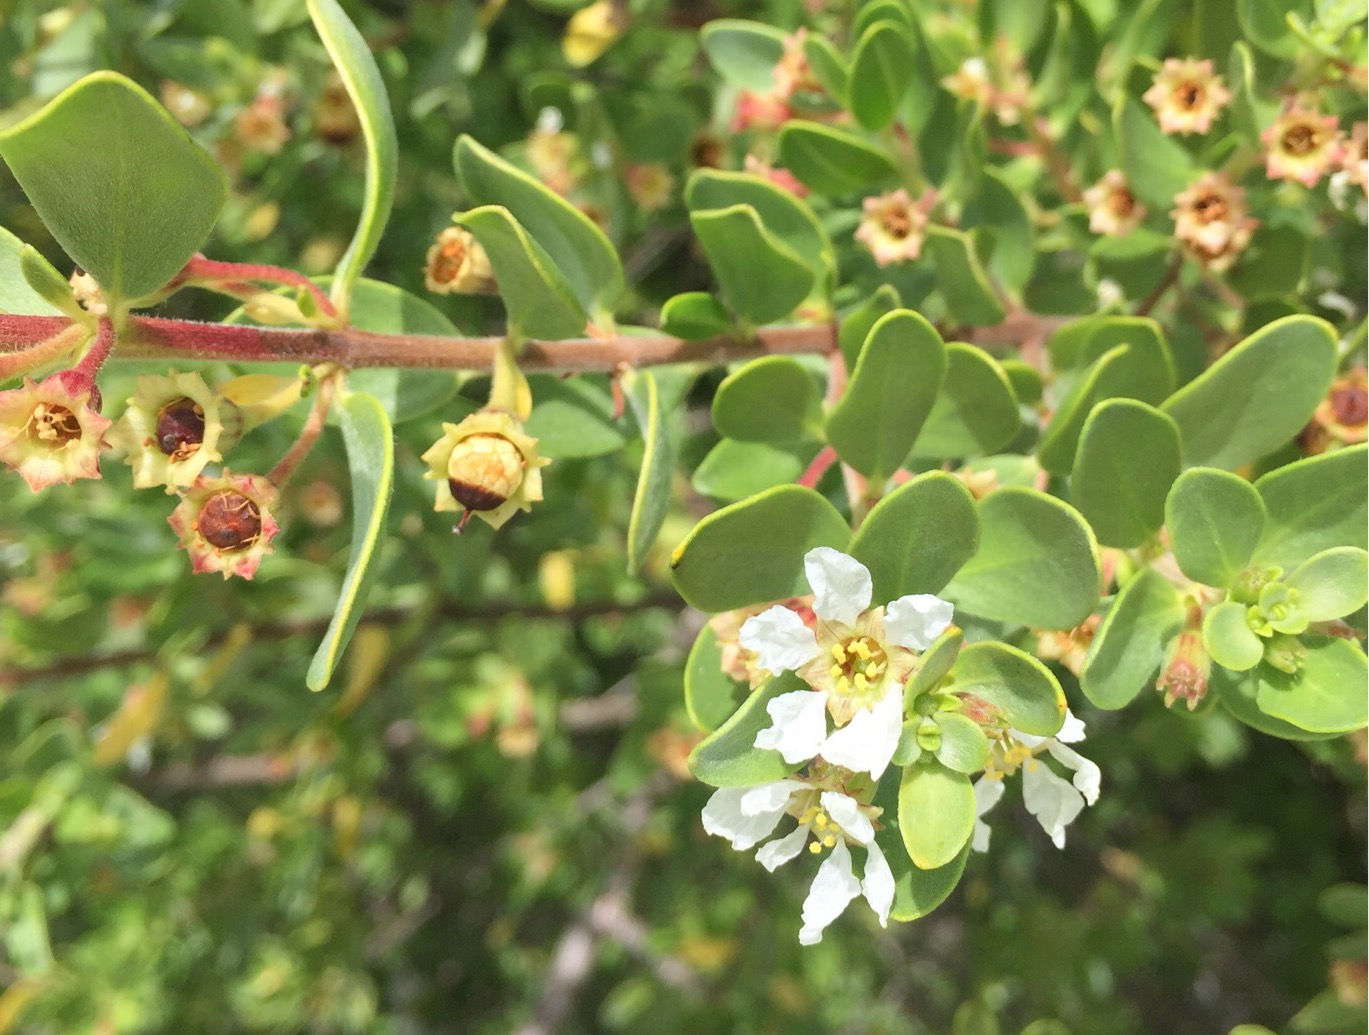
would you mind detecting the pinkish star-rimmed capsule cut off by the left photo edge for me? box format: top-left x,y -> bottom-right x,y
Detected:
0,370 -> 114,491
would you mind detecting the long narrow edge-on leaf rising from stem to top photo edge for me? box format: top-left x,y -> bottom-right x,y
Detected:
308,0 -> 400,309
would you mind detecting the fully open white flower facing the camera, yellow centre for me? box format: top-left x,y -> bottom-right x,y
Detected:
739,546 -> 951,779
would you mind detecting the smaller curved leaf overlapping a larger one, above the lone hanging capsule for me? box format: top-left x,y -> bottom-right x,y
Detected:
453,205 -> 587,338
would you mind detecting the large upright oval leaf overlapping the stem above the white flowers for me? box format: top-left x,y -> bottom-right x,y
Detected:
827,309 -> 946,483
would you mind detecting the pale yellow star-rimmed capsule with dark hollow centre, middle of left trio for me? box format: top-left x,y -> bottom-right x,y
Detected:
110,371 -> 242,491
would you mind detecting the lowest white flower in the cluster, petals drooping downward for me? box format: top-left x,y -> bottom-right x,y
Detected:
704,778 -> 894,945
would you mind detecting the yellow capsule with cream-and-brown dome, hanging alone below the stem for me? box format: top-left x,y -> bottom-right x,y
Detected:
423,409 -> 552,528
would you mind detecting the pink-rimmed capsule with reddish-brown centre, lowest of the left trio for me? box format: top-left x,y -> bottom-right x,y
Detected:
167,470 -> 279,579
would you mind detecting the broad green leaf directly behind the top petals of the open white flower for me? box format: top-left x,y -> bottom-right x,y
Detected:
849,471 -> 979,604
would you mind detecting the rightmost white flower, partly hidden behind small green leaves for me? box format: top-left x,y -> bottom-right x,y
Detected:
973,711 -> 1102,852
